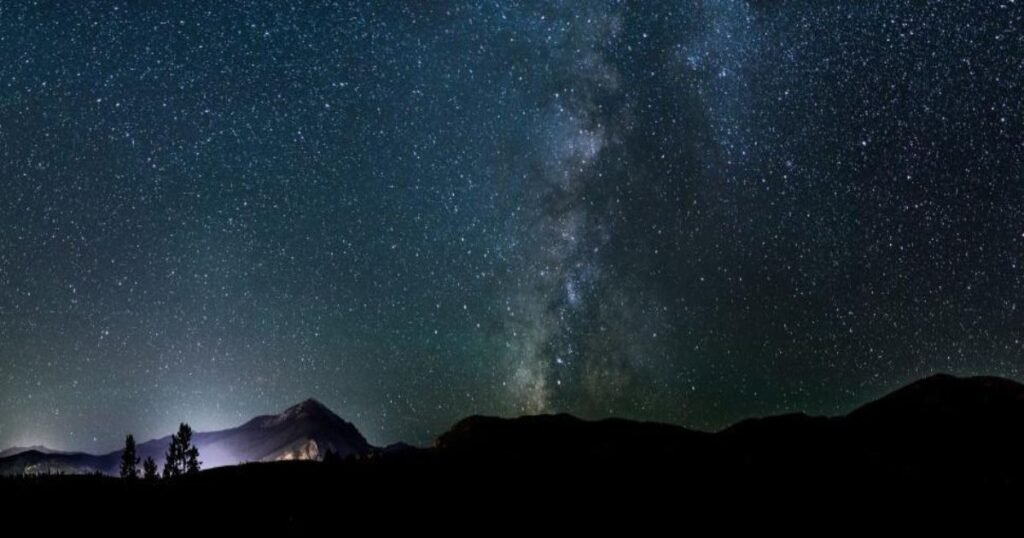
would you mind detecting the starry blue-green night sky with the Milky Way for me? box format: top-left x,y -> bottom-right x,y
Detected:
0,0 -> 1024,451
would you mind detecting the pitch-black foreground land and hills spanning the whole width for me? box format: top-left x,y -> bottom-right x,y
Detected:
0,375 -> 1024,527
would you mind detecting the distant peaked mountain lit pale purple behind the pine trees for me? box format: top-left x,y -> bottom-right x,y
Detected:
0,399 -> 372,474
